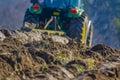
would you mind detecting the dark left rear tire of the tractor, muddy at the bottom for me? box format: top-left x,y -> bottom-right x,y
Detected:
21,9 -> 39,31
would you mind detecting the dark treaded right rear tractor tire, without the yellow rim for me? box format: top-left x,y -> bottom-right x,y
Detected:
67,17 -> 84,42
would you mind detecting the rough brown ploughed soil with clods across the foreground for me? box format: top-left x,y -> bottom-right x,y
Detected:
0,30 -> 120,80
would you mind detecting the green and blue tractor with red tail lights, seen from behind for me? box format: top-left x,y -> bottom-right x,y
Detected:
21,0 -> 93,46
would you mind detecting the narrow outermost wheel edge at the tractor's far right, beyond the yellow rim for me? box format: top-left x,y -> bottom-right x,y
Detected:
86,24 -> 93,47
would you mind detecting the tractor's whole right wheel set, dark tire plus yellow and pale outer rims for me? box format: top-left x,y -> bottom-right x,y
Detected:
67,13 -> 93,47
